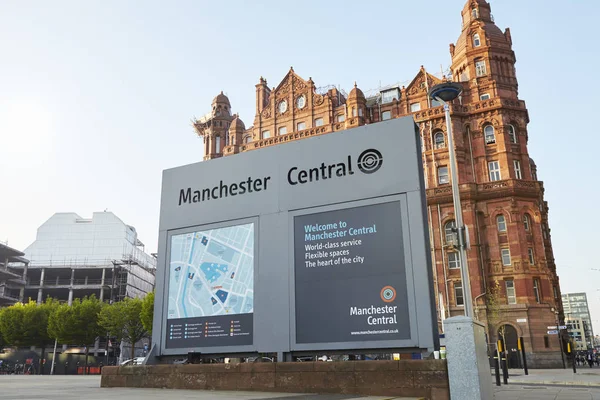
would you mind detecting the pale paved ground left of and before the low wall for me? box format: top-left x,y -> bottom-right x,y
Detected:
0,375 -> 408,400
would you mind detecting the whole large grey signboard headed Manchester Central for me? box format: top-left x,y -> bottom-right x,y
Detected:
153,118 -> 437,355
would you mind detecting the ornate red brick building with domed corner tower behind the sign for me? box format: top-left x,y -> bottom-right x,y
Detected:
194,0 -> 563,367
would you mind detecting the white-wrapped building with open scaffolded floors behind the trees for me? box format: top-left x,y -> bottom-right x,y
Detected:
13,211 -> 156,303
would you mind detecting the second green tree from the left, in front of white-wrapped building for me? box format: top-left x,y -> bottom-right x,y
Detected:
48,295 -> 105,373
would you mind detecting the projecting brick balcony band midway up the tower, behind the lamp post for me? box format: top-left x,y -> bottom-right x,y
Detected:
427,179 -> 544,204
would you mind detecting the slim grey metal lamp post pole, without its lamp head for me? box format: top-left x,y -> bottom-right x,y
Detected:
437,101 -> 473,318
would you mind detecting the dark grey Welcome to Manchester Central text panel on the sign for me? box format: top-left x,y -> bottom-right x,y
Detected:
294,201 -> 410,343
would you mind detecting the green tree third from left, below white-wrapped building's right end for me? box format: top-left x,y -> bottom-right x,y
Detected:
100,298 -> 147,358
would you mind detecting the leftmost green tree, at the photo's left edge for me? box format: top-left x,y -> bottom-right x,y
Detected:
0,298 -> 58,374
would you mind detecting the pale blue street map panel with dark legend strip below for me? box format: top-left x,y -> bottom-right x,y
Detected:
167,224 -> 254,347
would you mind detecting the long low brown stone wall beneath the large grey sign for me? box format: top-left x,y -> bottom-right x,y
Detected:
101,360 -> 450,400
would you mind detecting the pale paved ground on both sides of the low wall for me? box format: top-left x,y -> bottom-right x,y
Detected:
0,368 -> 600,400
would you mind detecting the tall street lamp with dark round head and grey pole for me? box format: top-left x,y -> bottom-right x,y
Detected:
429,82 -> 473,318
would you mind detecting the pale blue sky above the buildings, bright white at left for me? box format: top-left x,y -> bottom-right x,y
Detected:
0,0 -> 600,330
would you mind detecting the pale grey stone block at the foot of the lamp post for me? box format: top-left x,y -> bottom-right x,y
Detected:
444,316 -> 494,400
